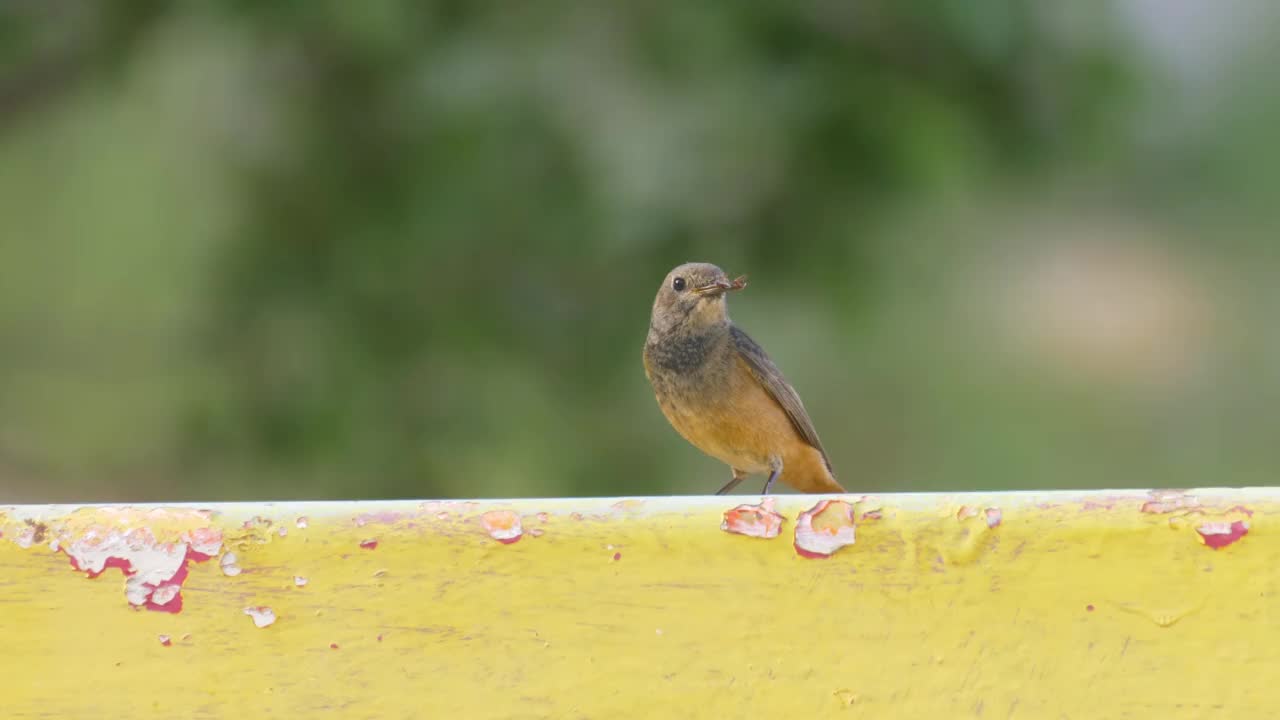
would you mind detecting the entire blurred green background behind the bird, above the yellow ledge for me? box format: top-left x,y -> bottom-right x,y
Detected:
0,0 -> 1280,502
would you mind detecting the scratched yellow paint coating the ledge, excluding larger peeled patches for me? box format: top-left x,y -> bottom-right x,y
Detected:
0,489 -> 1280,719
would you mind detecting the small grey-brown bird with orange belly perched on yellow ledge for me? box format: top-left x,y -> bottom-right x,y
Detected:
644,263 -> 845,495
